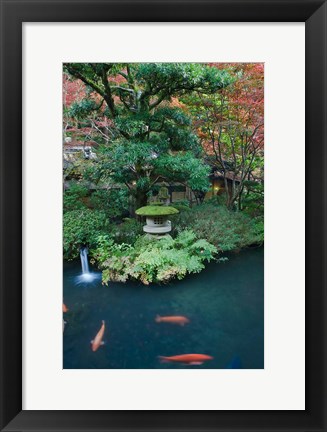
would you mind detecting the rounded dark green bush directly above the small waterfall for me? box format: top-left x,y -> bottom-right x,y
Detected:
63,209 -> 108,259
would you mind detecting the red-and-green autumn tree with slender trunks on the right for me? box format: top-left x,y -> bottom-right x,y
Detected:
184,63 -> 264,209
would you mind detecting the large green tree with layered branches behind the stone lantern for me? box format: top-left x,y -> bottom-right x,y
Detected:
64,63 -> 232,207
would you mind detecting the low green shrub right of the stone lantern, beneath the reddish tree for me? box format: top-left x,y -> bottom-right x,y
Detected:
173,203 -> 264,252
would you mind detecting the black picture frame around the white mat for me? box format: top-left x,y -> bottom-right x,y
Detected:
0,0 -> 327,432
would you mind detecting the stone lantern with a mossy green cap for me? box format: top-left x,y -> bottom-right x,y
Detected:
135,205 -> 179,235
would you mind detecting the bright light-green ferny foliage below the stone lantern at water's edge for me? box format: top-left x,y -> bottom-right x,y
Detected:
93,231 -> 217,285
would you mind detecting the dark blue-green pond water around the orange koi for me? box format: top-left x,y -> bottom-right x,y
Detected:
63,248 -> 264,369
